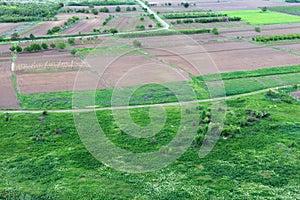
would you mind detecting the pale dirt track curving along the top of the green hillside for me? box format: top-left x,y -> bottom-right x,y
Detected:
0,85 -> 293,114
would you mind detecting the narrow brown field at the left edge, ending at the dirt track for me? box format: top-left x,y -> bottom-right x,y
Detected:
0,57 -> 20,109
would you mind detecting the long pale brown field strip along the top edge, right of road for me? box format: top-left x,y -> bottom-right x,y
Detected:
151,0 -> 292,12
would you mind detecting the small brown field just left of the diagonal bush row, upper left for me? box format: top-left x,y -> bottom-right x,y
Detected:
21,20 -> 65,37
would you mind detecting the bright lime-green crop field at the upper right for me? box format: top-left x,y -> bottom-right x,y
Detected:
221,10 -> 300,25
